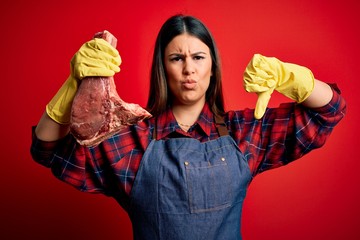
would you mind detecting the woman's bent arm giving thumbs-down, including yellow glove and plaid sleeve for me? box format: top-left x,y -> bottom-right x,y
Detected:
244,54 -> 346,173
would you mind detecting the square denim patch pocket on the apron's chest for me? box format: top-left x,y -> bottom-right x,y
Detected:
184,157 -> 232,213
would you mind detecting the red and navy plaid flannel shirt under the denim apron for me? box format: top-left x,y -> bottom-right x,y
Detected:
31,86 -> 346,202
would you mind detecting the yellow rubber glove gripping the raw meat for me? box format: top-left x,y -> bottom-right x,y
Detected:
46,38 -> 121,124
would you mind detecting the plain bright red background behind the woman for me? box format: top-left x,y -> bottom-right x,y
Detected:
0,0 -> 360,240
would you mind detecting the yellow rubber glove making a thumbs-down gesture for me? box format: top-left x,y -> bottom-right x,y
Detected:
244,54 -> 315,119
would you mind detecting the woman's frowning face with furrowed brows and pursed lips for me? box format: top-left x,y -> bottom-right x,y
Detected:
164,33 -> 212,105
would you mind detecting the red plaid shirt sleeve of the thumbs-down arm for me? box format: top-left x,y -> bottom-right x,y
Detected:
232,87 -> 346,176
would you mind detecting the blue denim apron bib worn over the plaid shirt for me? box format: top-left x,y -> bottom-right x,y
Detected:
128,117 -> 251,240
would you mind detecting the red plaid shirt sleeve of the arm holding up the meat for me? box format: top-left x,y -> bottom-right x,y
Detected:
30,124 -> 148,195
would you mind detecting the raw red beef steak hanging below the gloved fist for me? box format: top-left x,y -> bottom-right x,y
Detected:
70,77 -> 151,146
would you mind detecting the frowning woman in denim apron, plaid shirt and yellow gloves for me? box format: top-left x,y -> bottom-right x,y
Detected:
31,15 -> 345,239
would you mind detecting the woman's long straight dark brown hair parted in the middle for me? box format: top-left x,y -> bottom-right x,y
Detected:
147,15 -> 224,116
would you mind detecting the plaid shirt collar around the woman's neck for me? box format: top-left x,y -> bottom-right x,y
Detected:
157,103 -> 214,139
